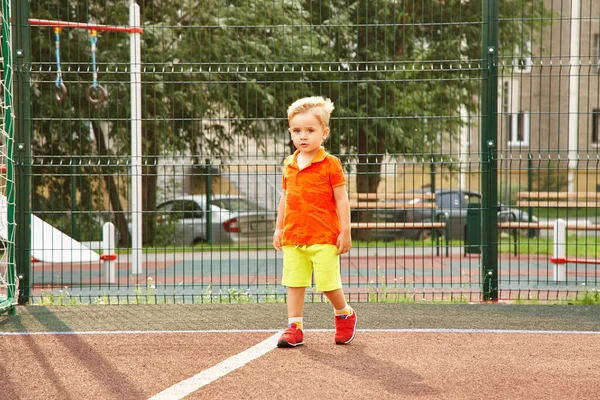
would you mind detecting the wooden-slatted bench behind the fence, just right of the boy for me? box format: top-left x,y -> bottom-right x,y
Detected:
349,193 -> 449,255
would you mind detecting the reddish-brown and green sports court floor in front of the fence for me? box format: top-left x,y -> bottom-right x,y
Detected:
0,303 -> 600,399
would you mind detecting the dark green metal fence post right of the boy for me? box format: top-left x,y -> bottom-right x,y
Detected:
481,0 -> 498,301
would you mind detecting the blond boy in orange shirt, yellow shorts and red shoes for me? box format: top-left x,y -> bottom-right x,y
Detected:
273,97 -> 356,347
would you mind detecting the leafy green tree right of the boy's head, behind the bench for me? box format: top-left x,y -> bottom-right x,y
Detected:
305,0 -> 549,192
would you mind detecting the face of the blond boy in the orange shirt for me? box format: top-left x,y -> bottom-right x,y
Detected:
289,110 -> 329,156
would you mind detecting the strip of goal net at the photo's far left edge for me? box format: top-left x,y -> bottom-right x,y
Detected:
0,0 -> 18,313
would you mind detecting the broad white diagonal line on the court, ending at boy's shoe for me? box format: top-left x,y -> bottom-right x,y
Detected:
150,331 -> 283,400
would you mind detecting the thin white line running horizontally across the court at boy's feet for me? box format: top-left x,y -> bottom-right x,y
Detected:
0,328 -> 600,336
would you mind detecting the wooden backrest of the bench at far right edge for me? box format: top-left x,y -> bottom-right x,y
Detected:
517,192 -> 600,208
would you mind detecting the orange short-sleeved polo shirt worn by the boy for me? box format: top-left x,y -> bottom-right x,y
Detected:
281,147 -> 346,245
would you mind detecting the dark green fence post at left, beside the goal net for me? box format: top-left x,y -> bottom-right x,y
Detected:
12,0 -> 31,304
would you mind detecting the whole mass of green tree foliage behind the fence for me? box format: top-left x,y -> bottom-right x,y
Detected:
31,0 -> 551,238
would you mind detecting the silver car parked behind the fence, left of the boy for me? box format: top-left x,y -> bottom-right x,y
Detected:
156,194 -> 277,246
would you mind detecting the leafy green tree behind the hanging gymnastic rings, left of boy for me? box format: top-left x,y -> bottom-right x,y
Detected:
27,0 -> 320,245
